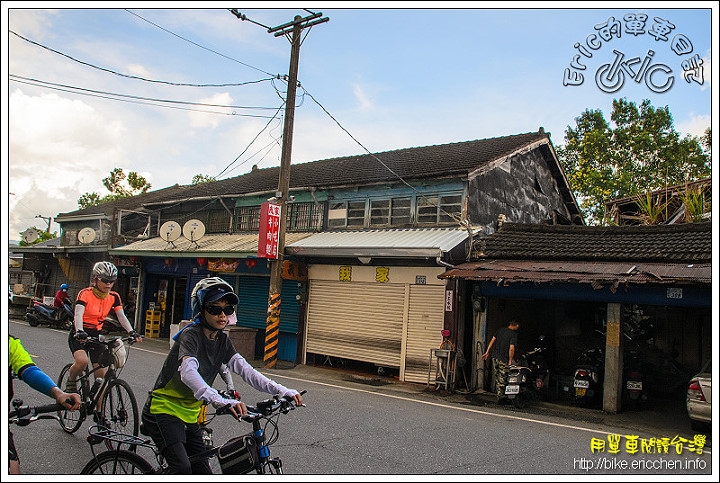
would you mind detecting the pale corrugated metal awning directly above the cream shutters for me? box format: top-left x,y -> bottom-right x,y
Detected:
285,228 -> 468,258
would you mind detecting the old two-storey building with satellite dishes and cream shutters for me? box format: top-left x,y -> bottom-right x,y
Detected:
12,128 -> 583,382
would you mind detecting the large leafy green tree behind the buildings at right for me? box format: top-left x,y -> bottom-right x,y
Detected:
557,98 -> 710,224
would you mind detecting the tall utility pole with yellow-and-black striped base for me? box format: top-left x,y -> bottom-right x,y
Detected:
230,9 -> 330,368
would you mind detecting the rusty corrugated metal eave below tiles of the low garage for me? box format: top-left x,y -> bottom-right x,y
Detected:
438,260 -> 712,287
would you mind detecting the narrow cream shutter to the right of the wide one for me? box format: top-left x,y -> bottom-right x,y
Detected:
403,285 -> 445,384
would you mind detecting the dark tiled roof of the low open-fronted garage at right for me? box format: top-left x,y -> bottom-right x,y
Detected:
473,223 -> 712,263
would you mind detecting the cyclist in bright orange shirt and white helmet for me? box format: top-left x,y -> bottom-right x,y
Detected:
65,262 -> 142,392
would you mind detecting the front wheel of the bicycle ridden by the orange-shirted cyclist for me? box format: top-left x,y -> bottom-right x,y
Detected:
98,379 -> 140,449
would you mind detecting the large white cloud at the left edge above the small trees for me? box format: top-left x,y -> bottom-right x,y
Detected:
8,89 -> 127,236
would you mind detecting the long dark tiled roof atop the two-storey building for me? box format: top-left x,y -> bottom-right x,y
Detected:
60,130 -> 549,216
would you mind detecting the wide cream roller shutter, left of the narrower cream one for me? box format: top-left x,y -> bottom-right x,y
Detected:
306,280 -> 404,367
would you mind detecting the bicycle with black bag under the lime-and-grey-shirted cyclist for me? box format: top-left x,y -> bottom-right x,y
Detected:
80,391 -> 307,475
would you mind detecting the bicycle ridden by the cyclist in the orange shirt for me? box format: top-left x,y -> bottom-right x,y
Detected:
57,335 -> 140,449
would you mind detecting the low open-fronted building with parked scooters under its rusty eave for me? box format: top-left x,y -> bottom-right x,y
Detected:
440,222 -> 712,411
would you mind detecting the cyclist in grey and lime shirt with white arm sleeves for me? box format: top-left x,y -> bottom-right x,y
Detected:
142,277 -> 302,474
